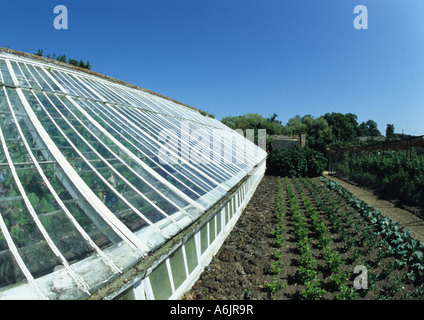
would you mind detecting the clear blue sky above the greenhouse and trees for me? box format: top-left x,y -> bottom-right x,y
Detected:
0,0 -> 424,134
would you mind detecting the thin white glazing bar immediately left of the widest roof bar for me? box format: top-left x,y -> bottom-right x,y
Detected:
5,87 -> 121,273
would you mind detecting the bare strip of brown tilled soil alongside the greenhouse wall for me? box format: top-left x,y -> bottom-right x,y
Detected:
184,177 -> 277,300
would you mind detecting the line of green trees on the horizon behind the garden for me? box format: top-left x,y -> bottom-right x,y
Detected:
221,112 -> 394,154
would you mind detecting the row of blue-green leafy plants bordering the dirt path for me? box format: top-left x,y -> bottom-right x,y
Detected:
323,178 -> 424,299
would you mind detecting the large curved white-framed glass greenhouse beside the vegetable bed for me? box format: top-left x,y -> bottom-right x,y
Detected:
0,49 -> 266,299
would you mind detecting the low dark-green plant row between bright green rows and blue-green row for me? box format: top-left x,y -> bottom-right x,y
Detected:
302,176 -> 423,300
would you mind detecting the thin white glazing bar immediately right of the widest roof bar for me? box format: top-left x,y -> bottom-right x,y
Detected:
29,90 -> 169,240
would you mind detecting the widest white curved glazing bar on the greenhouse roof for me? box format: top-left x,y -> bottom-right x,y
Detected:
6,60 -> 149,255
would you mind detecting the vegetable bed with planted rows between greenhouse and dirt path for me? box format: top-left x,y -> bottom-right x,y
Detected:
185,176 -> 424,300
